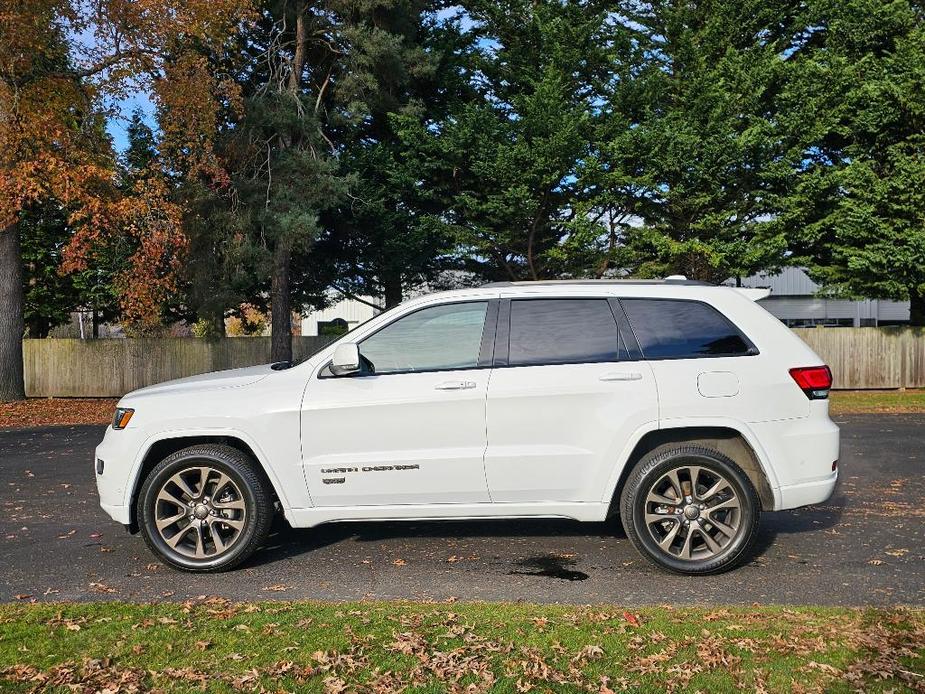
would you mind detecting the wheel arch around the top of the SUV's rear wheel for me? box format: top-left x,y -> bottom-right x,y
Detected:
607,424 -> 776,517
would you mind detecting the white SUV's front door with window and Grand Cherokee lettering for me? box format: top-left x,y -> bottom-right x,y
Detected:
302,301 -> 497,506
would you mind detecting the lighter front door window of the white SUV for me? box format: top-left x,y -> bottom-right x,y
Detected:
360,301 -> 488,374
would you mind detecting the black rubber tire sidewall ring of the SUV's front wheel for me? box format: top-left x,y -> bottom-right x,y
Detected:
138,451 -> 259,571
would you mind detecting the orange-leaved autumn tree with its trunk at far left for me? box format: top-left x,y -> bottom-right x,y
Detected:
0,0 -> 250,401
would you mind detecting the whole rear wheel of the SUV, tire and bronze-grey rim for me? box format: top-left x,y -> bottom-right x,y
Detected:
620,444 -> 761,575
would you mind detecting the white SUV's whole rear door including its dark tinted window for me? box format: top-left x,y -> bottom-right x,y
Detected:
485,296 -> 658,502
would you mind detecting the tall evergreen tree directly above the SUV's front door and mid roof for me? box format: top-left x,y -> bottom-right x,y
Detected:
394,0 -> 612,280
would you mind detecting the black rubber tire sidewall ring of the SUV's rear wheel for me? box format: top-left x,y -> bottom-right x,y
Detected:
623,449 -> 759,574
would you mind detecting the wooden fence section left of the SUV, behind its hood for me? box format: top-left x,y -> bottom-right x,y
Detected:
23,337 -> 333,398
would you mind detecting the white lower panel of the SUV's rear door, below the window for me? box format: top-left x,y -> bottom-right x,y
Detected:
485,362 -> 658,502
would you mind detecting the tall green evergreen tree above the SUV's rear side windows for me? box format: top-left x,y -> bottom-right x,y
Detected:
582,0 -> 800,282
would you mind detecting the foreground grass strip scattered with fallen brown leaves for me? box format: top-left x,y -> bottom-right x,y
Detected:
0,599 -> 925,692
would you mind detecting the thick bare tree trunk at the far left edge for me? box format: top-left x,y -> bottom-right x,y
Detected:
0,224 -> 26,402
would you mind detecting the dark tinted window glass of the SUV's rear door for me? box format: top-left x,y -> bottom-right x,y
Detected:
508,299 -> 620,366
